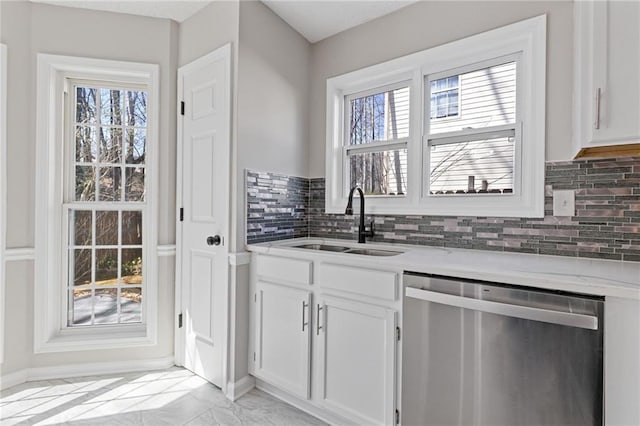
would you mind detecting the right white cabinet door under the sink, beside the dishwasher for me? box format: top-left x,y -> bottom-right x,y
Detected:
314,295 -> 396,425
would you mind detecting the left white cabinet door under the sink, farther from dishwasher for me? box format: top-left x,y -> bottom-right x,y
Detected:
254,282 -> 311,399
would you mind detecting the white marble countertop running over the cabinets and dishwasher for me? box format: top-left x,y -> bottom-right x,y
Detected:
247,238 -> 640,300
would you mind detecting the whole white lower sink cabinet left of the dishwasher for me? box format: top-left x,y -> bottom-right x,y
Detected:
249,254 -> 400,425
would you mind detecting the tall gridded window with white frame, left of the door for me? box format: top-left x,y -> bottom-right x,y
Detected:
34,54 -> 158,353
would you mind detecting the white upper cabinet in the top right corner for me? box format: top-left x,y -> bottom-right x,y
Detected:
574,0 -> 640,152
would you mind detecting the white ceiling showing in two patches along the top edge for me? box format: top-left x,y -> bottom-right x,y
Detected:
29,0 -> 417,43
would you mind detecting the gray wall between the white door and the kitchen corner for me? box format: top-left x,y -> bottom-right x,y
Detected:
236,2 -> 311,247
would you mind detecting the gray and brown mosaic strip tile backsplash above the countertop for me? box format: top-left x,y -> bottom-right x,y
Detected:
247,157 -> 640,262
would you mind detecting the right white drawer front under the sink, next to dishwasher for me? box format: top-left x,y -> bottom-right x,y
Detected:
317,263 -> 398,300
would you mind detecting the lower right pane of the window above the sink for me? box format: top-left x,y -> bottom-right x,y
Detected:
429,137 -> 514,194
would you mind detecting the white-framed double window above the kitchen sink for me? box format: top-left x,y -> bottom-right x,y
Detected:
326,16 -> 546,217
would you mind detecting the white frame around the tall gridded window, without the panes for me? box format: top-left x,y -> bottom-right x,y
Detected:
34,54 -> 159,353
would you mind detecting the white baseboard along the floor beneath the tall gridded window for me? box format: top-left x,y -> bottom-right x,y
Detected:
0,356 -> 174,389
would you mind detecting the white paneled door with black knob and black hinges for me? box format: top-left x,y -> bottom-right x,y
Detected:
176,45 -> 231,387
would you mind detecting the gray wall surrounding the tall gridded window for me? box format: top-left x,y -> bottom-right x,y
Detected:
0,2 -> 177,374
